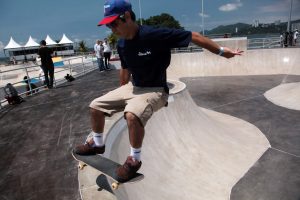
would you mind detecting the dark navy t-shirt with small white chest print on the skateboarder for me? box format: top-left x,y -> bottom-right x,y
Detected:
117,26 -> 192,88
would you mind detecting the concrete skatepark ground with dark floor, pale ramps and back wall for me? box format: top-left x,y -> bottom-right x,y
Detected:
0,38 -> 300,200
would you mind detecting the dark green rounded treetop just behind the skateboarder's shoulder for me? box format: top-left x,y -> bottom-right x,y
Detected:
142,13 -> 183,29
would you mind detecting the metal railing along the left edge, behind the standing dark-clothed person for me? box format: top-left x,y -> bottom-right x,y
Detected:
0,54 -> 98,109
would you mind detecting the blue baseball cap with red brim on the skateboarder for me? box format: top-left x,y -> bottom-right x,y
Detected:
98,0 -> 132,26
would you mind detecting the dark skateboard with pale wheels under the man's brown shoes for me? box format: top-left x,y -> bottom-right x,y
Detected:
72,151 -> 144,190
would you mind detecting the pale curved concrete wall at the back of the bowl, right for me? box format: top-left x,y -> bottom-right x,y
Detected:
168,46 -> 300,78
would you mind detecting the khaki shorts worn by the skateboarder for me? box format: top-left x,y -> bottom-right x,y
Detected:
90,82 -> 168,126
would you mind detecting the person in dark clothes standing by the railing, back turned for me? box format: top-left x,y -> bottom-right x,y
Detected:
38,40 -> 54,89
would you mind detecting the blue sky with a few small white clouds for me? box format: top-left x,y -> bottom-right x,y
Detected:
0,0 -> 300,57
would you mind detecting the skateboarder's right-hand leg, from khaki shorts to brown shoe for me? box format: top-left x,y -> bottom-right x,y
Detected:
116,88 -> 168,181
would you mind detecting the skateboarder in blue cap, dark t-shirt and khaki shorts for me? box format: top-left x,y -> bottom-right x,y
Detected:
74,0 -> 242,180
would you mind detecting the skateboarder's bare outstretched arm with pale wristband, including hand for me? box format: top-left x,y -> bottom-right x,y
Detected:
192,32 -> 243,58
